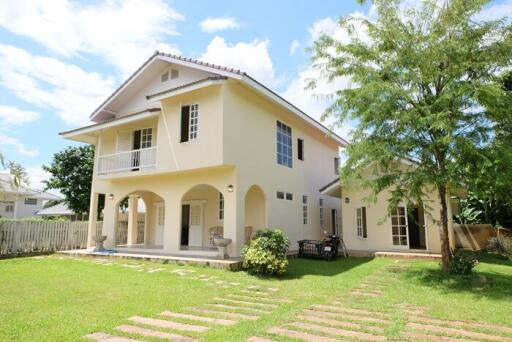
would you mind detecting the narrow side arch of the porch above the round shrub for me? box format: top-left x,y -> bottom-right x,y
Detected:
244,185 -> 267,243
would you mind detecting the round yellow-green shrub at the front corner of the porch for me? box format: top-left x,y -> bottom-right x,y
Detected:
242,229 -> 290,275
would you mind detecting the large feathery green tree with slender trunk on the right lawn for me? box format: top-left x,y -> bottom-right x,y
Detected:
310,0 -> 512,271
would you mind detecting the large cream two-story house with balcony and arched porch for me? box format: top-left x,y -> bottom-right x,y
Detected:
61,52 -> 346,256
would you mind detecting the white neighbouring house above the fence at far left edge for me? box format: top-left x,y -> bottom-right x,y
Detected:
0,173 -> 61,219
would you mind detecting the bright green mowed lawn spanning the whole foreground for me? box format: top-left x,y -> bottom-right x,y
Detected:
0,255 -> 512,342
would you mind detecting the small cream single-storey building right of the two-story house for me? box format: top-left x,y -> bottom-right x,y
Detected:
320,164 -> 459,255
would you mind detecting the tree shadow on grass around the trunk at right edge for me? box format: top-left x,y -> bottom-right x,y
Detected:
402,254 -> 512,300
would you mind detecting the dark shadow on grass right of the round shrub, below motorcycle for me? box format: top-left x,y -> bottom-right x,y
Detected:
281,258 -> 373,280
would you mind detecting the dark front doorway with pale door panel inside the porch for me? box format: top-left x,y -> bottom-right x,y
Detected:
181,201 -> 204,247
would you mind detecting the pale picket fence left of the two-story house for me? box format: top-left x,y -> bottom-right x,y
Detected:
0,220 -> 103,255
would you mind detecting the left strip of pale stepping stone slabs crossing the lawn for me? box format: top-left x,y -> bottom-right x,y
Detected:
86,284 -> 292,342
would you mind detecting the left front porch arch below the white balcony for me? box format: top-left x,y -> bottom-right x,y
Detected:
115,190 -> 165,248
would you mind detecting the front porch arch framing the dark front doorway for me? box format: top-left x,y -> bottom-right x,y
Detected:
180,184 -> 225,251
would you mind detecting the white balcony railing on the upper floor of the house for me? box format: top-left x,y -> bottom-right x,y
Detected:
98,147 -> 156,175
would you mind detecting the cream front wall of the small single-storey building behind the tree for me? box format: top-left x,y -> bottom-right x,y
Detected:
341,186 -> 441,253
